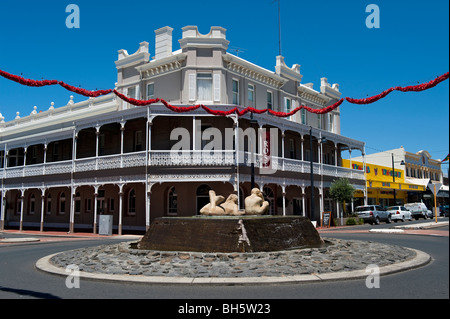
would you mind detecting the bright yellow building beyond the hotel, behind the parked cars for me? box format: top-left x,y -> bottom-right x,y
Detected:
342,159 -> 426,206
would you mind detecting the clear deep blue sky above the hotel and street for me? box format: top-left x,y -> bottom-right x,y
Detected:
0,0 -> 449,171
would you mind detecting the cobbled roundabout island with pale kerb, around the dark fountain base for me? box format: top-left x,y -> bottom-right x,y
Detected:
36,238 -> 431,284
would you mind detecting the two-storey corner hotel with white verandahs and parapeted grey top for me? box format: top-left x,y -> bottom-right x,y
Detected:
0,26 -> 365,234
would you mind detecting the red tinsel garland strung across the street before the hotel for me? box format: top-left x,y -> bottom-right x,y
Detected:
0,70 -> 449,117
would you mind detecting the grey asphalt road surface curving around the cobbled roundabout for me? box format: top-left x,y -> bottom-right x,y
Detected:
0,219 -> 449,302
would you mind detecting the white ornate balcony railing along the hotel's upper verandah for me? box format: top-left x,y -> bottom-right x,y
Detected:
0,150 -> 364,180
